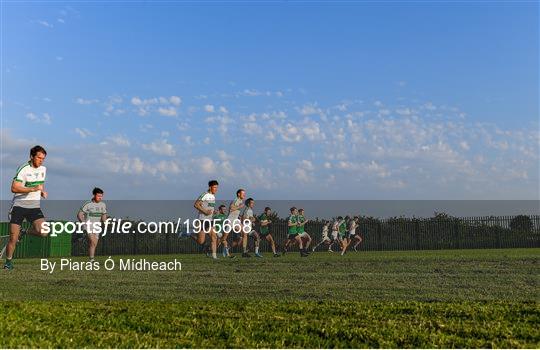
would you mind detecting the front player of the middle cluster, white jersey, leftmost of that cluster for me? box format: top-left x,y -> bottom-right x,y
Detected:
191,180 -> 219,259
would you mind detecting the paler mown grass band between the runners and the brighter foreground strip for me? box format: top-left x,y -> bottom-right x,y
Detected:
0,249 -> 540,302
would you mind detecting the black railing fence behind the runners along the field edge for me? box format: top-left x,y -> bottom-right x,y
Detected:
72,215 -> 540,255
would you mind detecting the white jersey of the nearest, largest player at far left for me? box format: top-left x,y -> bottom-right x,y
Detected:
12,161 -> 47,208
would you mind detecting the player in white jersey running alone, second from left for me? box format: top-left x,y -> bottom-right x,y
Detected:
77,187 -> 107,261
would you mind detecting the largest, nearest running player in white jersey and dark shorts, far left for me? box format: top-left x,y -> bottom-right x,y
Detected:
4,146 -> 48,270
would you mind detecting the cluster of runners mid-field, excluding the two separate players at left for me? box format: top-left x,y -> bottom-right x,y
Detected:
188,180 -> 363,259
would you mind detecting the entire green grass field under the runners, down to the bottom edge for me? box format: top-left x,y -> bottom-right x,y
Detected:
0,249 -> 540,348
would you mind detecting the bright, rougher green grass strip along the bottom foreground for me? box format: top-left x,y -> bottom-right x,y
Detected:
0,300 -> 540,348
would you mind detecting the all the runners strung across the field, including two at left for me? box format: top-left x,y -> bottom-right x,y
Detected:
0,146 -> 362,270
